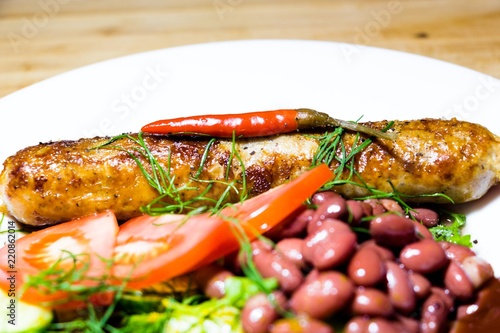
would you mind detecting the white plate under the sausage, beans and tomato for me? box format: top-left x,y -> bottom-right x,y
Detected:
0,40 -> 500,275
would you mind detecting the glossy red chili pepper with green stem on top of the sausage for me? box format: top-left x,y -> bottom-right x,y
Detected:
141,109 -> 395,140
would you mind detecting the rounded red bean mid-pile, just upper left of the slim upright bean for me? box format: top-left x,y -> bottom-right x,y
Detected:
347,246 -> 386,287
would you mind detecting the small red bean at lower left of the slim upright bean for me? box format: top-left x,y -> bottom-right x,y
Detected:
351,287 -> 394,317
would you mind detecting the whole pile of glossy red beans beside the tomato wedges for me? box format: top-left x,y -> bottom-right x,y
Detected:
193,192 -> 494,333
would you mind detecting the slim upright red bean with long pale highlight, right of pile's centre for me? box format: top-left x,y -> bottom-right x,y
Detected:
386,261 -> 416,314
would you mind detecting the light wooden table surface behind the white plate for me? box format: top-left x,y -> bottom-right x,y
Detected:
0,0 -> 500,97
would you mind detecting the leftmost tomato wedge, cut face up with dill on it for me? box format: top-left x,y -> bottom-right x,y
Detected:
0,212 -> 118,303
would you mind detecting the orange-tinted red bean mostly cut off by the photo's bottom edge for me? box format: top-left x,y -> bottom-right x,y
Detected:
269,316 -> 335,333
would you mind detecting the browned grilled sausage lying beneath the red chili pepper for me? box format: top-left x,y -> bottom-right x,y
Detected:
0,119 -> 500,226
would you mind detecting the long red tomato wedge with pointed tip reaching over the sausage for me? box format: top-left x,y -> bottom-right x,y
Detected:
112,165 -> 333,288
